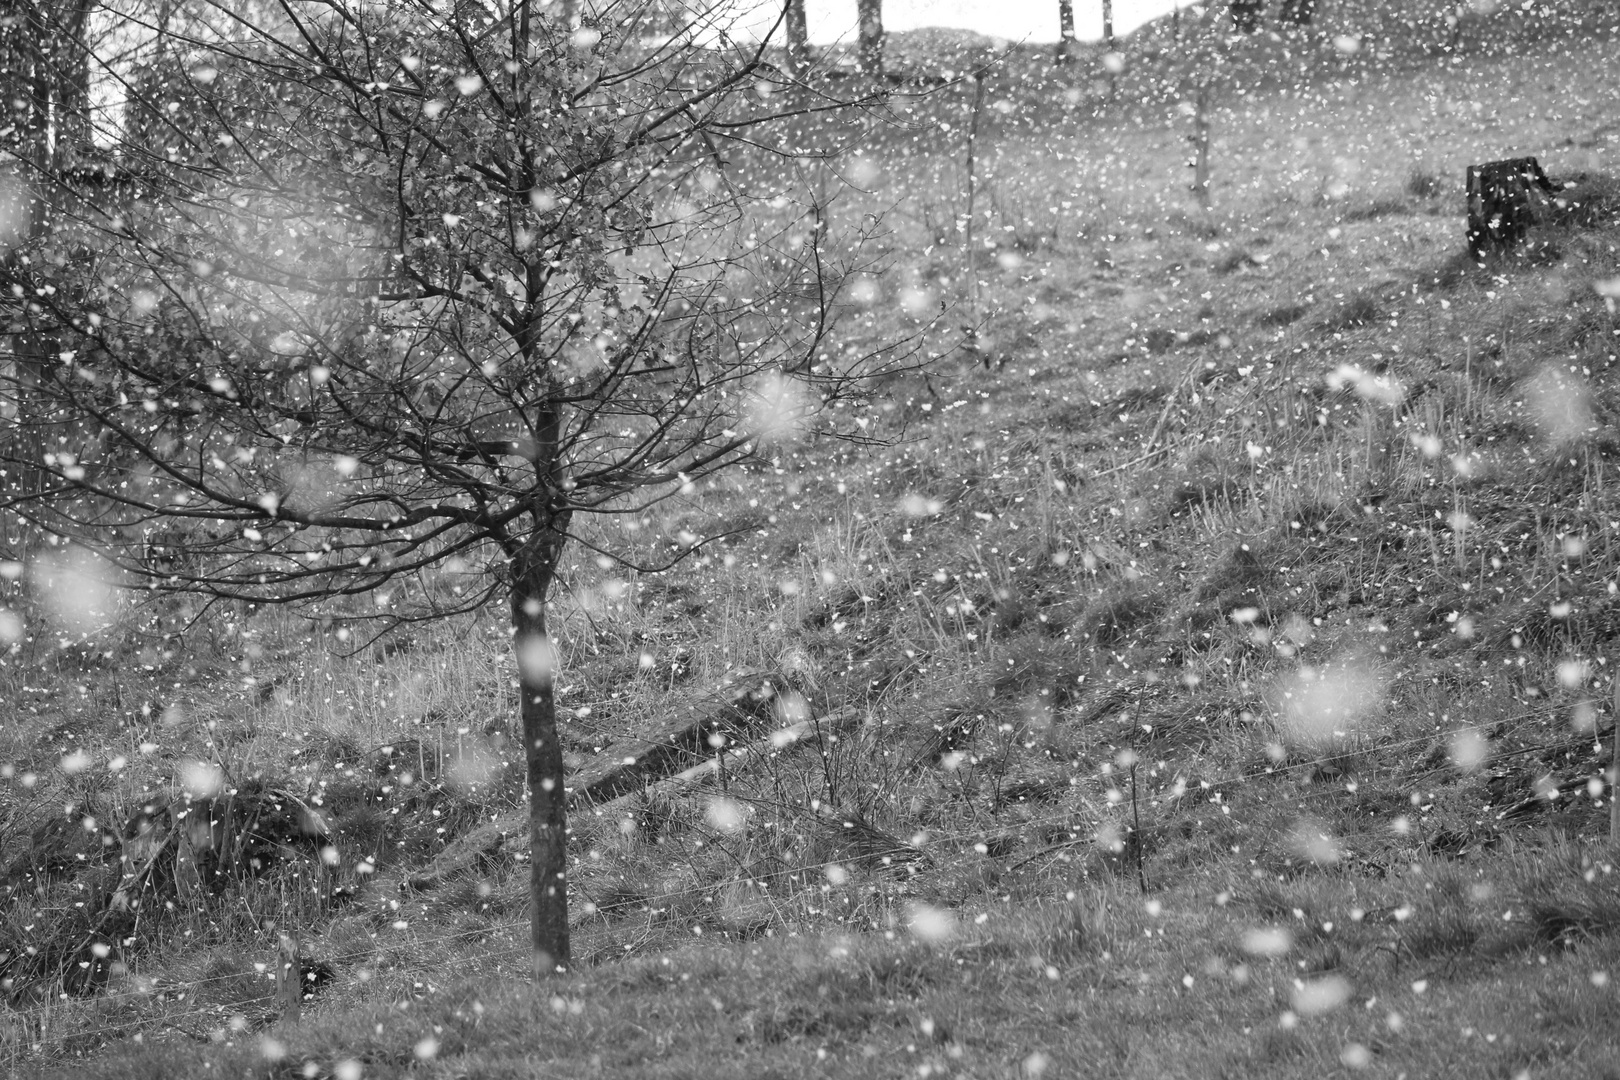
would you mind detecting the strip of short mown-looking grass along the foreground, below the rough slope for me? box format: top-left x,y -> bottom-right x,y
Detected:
12,848 -> 1620,1078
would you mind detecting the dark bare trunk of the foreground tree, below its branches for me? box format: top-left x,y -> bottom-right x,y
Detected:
510,526 -> 570,978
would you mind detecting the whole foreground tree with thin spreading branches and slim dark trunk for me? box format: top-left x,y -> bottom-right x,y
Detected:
0,0 -> 909,972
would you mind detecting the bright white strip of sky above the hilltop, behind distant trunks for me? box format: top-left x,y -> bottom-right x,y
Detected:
758,0 -> 1191,42
